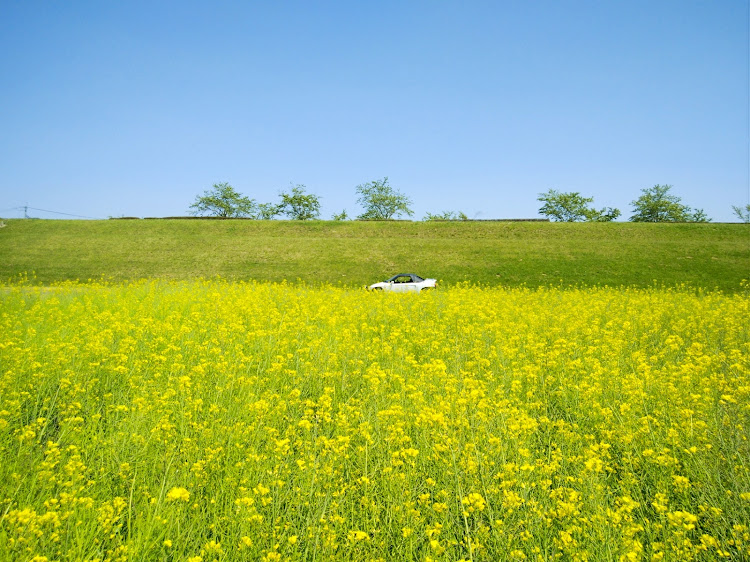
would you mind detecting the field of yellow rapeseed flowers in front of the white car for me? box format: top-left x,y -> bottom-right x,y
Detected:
0,280 -> 750,562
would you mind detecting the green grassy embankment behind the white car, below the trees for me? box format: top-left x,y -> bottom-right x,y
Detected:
0,219 -> 750,291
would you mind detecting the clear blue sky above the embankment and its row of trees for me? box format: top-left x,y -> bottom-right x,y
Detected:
0,0 -> 750,221
